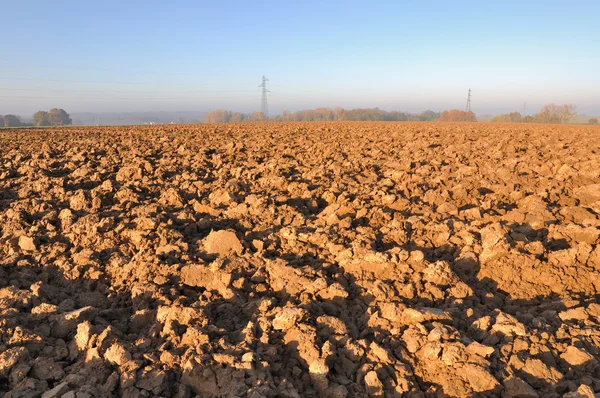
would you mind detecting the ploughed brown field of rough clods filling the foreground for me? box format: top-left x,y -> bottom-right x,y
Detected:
0,123 -> 600,398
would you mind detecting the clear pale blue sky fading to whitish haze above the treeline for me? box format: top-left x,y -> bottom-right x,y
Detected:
0,0 -> 600,116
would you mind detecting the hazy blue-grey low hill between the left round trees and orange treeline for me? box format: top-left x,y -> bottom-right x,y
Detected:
70,111 -> 206,126
